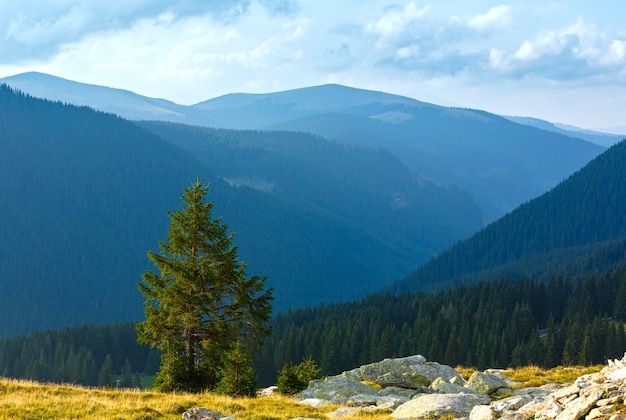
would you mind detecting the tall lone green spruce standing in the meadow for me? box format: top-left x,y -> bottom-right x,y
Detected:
137,180 -> 272,391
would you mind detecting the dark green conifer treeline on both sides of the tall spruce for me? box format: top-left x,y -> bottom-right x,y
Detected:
0,264 -> 626,386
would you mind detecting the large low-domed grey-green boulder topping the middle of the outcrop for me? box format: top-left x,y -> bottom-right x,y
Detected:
342,355 -> 463,389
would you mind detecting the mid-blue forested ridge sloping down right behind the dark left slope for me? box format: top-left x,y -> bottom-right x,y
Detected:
138,122 -> 482,262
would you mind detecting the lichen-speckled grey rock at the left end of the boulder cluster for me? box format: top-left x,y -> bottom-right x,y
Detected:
296,376 -> 378,405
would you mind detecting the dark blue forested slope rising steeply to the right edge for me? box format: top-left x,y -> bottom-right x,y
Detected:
394,141 -> 626,291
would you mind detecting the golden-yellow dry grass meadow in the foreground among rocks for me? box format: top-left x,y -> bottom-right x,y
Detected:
0,366 -> 603,420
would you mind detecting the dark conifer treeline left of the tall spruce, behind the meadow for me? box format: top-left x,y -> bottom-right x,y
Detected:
0,323 -> 160,387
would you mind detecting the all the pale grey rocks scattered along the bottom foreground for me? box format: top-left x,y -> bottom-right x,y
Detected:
183,354 -> 626,420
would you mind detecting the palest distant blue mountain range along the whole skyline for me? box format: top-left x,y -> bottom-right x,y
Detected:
0,73 -> 604,221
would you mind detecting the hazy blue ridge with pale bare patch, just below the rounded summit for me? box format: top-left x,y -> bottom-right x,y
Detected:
268,103 -> 604,221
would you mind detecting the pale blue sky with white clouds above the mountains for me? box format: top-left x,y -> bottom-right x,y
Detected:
0,0 -> 626,133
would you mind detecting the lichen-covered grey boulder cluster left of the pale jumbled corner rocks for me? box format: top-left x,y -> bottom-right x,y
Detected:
297,355 -> 509,418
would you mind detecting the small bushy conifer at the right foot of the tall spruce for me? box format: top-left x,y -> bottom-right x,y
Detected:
215,340 -> 256,397
